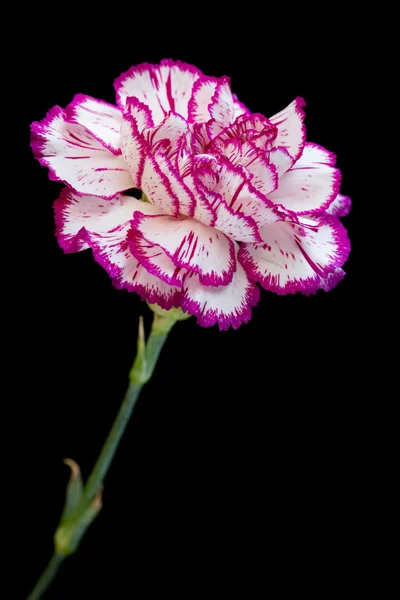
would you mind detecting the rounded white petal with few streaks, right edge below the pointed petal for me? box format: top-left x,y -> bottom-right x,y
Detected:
268,143 -> 340,215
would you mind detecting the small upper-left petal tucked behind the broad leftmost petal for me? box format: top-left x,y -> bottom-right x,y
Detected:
65,94 -> 122,154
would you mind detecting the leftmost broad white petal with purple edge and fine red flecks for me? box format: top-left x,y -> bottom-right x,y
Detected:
31,106 -> 134,198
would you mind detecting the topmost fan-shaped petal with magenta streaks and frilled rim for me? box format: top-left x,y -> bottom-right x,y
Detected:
114,60 -> 202,125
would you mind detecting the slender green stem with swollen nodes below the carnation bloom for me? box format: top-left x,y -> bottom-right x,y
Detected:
28,311 -> 179,600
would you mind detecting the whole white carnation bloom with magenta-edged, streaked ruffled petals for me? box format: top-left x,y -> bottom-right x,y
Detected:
32,60 -> 350,329
